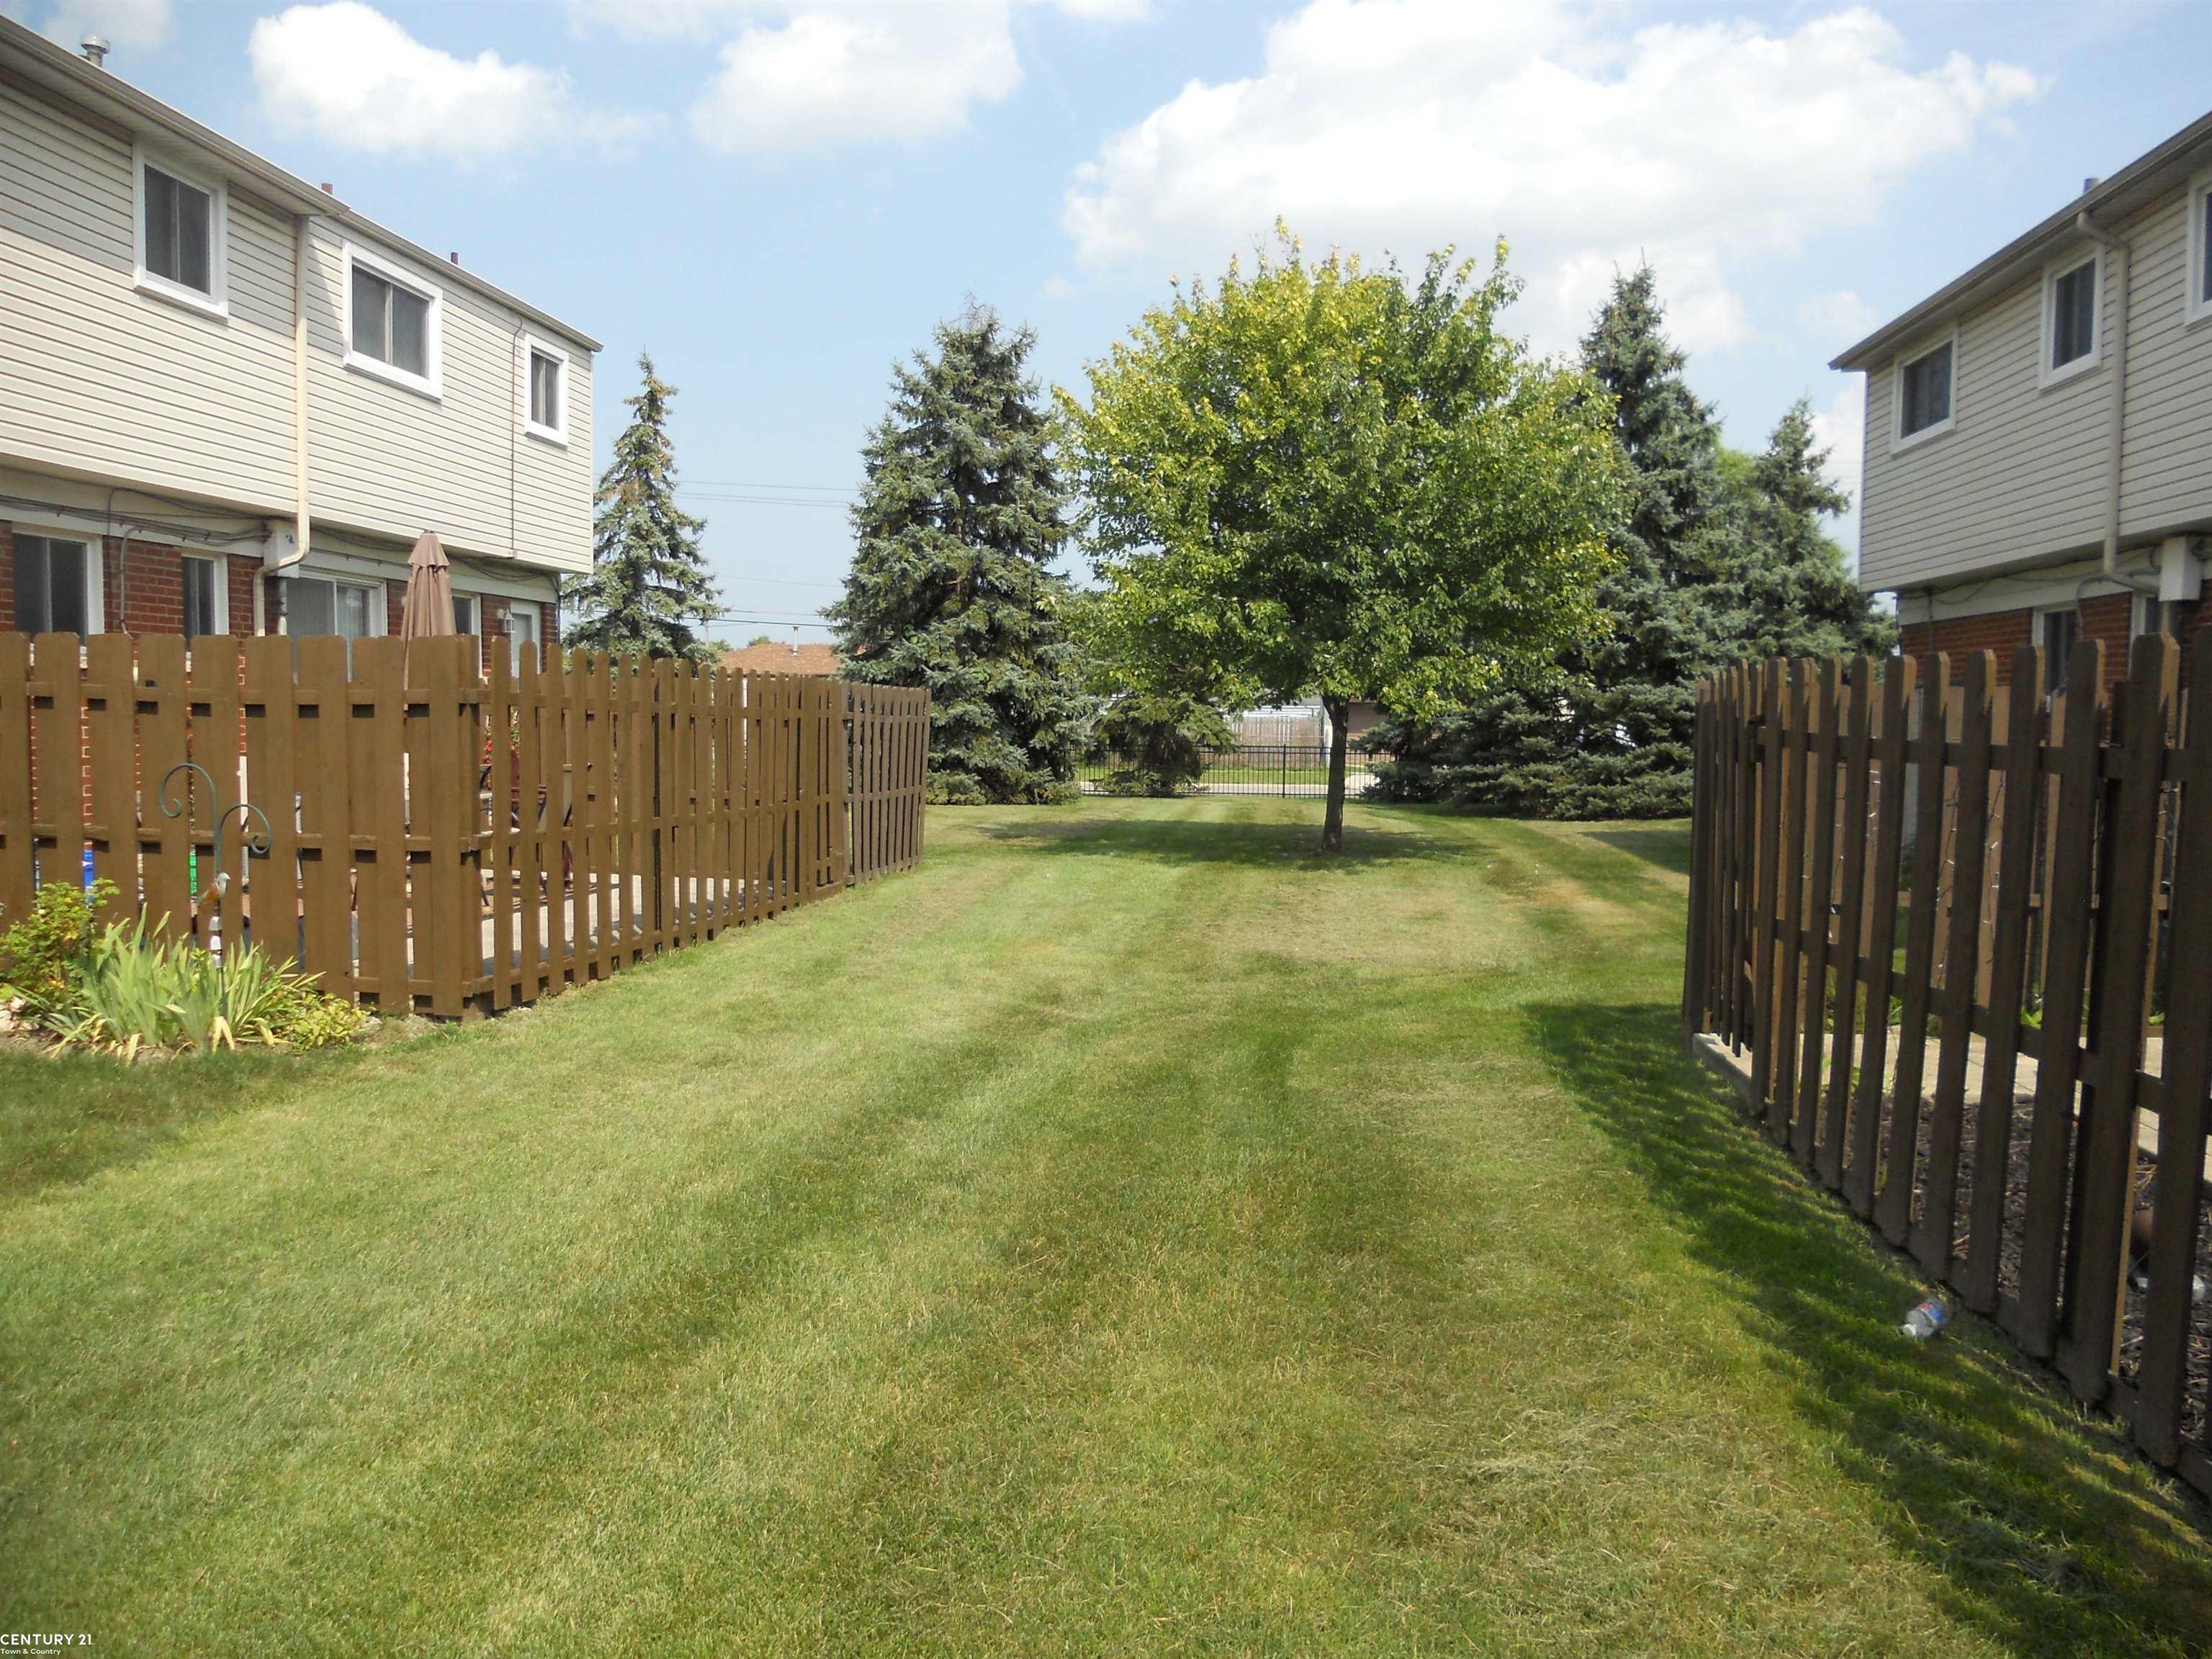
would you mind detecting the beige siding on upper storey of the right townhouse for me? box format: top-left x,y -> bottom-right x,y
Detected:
1861,190 -> 2212,588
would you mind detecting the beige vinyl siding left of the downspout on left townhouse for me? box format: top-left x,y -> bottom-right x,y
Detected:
0,76 -> 292,513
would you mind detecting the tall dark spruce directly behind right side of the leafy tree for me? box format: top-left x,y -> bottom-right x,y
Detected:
1374,266 -> 1741,819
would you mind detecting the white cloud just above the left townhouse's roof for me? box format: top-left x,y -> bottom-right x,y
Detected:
246,0 -> 650,161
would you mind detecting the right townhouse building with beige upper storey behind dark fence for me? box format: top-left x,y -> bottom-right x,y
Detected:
1832,115 -> 2212,679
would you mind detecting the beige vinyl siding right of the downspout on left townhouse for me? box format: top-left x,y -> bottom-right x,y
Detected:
307,219 -> 593,571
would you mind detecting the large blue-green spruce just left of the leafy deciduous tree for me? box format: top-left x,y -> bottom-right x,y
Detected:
827,312 -> 1088,803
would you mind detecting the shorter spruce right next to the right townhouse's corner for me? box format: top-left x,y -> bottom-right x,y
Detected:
1730,398 -> 1896,657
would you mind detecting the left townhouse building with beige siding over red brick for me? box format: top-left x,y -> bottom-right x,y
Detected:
0,16 -> 600,664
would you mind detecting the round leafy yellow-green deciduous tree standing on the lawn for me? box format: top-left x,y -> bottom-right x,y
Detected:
1062,228 -> 1622,852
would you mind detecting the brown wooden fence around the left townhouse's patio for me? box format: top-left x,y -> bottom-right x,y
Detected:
0,635 -> 929,1017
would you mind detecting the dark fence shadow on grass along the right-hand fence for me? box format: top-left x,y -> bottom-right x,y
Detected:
1529,1004 -> 2212,1655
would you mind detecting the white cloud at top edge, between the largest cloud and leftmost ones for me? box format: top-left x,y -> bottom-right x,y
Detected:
690,0 -> 1022,150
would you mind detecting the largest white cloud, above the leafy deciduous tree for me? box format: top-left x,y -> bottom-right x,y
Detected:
1064,0 -> 2039,362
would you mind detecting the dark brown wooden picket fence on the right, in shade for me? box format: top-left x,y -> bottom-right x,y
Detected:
1683,633 -> 2212,1491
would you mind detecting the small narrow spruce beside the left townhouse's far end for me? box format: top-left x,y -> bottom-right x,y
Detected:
559,351 -> 721,662
